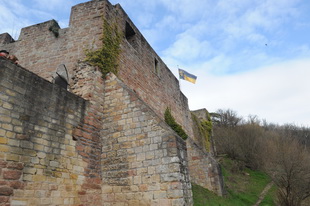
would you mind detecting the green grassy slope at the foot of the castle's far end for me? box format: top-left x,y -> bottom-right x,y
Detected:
193,158 -> 275,206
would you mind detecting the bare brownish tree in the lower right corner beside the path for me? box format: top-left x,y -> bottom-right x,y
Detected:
266,136 -> 310,206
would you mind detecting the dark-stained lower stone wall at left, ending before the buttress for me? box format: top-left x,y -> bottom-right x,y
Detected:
0,58 -> 95,206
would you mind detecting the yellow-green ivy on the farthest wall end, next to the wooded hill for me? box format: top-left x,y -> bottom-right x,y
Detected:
191,112 -> 212,152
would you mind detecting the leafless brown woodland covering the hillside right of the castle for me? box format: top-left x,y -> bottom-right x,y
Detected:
211,109 -> 310,206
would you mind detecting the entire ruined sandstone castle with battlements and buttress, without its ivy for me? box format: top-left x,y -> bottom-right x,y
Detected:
0,0 -> 223,206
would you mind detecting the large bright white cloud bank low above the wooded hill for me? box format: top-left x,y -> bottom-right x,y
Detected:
181,59 -> 310,126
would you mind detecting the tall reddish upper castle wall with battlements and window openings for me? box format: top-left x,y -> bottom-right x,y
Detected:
0,0 -> 192,138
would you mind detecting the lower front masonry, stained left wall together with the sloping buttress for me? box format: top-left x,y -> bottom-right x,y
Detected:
0,58 -> 192,206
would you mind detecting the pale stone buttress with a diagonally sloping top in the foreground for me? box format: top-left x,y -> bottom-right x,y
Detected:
101,71 -> 193,205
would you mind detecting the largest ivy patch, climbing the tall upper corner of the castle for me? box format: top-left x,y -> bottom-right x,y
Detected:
85,18 -> 122,76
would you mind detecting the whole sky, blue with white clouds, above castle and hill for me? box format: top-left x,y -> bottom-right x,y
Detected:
0,0 -> 310,126
